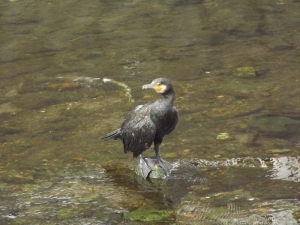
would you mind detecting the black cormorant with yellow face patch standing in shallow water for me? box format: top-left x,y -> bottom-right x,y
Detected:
103,78 -> 178,178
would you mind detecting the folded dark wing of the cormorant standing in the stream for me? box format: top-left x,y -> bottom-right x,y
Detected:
121,104 -> 156,157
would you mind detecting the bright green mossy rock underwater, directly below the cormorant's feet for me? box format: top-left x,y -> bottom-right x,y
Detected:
124,207 -> 171,222
